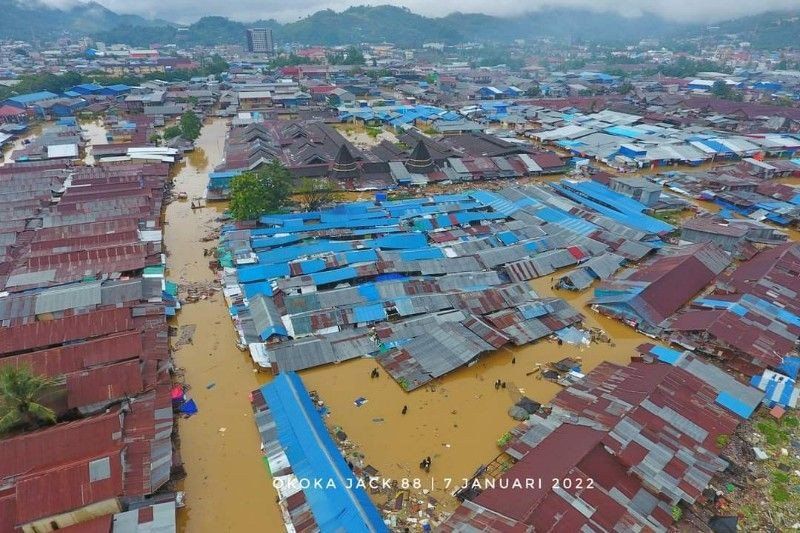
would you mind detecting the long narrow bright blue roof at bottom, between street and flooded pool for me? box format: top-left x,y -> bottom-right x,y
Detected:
261,372 -> 388,533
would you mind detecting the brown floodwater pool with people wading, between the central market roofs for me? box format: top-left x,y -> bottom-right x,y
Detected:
301,278 -> 650,510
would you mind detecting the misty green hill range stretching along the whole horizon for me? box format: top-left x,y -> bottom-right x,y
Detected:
0,0 -> 800,48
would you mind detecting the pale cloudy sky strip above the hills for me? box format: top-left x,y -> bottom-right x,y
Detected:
43,0 -> 800,22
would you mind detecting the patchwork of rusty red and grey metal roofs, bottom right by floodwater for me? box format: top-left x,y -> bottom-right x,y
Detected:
439,352 -> 763,533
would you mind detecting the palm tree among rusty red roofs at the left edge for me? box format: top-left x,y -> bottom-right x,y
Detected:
0,366 -> 56,432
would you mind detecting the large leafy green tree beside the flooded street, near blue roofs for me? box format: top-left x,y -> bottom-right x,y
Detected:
230,159 -> 292,220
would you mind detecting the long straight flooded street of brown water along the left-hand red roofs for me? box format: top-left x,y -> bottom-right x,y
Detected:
165,120 -> 283,533
